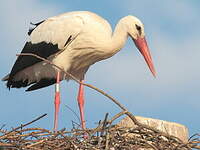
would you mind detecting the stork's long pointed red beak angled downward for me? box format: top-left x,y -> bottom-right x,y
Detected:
133,37 -> 156,77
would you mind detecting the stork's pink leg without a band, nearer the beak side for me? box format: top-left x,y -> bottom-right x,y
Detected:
77,80 -> 86,129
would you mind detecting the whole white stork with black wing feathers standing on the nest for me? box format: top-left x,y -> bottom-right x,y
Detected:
2,11 -> 156,131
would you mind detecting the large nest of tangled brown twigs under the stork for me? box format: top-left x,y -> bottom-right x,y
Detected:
0,113 -> 200,150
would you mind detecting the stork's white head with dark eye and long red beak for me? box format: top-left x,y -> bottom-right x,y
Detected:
124,16 -> 156,77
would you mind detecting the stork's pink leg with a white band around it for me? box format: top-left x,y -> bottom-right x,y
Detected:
54,72 -> 60,131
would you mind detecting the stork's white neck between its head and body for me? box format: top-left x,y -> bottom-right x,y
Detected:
111,18 -> 128,55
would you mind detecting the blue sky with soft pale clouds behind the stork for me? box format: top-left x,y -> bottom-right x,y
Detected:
0,0 -> 200,134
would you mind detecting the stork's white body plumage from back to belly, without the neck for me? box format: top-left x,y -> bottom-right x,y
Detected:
30,12 -> 112,79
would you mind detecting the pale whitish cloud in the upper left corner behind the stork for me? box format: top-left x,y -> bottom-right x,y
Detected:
0,0 -> 62,57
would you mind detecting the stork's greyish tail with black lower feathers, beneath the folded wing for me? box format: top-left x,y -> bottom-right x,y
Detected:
2,62 -> 64,91
